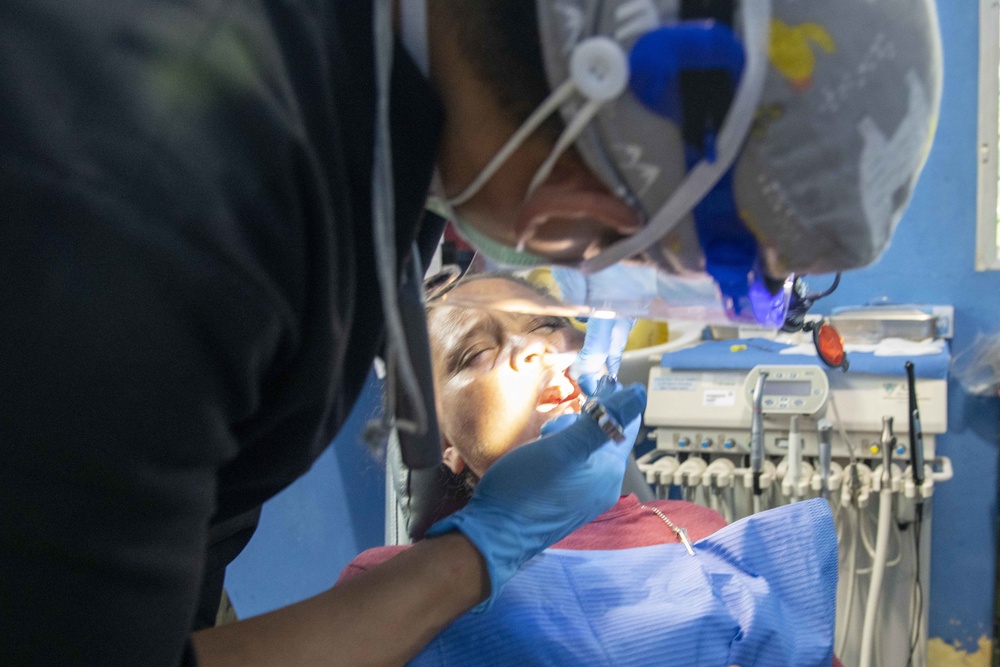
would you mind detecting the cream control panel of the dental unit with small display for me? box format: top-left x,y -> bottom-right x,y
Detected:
645,361 -> 948,462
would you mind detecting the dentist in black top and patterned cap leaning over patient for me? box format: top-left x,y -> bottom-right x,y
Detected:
0,0 -> 940,665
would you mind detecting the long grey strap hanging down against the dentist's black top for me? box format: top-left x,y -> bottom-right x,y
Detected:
372,0 -> 427,434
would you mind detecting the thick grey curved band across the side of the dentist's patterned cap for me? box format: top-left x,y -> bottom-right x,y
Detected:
579,0 -> 771,274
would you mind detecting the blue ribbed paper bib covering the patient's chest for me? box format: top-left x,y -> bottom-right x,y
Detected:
410,499 -> 837,667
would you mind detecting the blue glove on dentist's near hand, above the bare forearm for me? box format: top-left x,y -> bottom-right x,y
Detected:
427,384 -> 646,611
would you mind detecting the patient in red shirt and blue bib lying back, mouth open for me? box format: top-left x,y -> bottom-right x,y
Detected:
338,277 -> 838,667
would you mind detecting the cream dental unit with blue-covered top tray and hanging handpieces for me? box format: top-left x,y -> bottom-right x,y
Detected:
639,339 -> 951,667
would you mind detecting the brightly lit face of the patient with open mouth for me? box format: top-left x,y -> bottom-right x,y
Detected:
427,278 -> 583,476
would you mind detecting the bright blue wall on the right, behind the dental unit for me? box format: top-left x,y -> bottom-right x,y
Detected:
814,0 -> 1000,650
